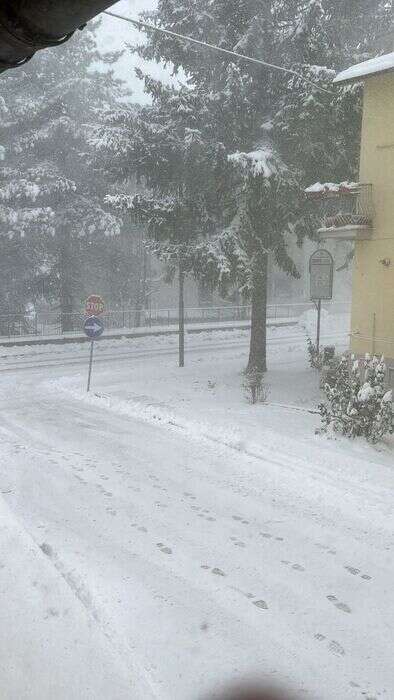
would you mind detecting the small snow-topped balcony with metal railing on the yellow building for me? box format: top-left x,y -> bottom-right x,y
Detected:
305,182 -> 373,241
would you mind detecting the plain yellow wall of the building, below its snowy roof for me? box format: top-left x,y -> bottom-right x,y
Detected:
351,72 -> 394,385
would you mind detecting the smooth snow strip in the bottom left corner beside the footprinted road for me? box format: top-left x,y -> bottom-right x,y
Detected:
0,496 -> 153,700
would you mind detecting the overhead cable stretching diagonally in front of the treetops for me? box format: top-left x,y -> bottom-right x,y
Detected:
103,10 -> 333,95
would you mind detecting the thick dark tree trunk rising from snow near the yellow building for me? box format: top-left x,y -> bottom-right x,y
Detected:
246,255 -> 268,372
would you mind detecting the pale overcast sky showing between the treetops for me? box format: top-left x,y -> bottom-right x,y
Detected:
98,0 -> 176,102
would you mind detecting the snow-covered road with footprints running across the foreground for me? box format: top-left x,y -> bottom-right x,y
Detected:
0,328 -> 394,700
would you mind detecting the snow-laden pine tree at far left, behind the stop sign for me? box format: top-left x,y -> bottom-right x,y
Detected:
0,21 -> 124,330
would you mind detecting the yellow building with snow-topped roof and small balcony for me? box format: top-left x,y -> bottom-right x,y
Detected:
320,52 -> 394,386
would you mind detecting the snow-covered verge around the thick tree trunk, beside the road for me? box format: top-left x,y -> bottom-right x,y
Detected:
48,320 -> 394,485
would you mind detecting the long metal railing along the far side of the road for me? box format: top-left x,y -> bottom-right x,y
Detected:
0,302 -> 350,338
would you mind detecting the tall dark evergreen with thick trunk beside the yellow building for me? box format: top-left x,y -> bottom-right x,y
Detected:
130,0 -> 391,371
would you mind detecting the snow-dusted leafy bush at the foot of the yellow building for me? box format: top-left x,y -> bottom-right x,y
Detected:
319,355 -> 393,443
